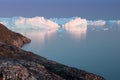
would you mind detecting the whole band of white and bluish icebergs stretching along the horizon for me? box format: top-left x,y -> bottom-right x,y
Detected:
0,17 -> 120,32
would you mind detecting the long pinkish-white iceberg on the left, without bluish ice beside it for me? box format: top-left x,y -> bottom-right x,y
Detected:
15,17 -> 59,30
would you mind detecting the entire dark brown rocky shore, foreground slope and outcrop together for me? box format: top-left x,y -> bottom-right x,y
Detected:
0,24 -> 105,80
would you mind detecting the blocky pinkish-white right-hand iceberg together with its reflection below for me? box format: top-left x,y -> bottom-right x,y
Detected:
62,17 -> 87,38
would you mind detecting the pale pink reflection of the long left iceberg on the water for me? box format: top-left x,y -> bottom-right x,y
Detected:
24,30 -> 56,49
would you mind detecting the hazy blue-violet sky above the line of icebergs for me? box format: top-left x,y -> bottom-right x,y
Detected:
0,0 -> 120,19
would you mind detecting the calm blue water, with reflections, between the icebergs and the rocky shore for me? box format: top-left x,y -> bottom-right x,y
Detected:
23,25 -> 120,80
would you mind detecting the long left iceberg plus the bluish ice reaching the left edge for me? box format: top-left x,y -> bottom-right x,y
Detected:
0,17 -> 59,30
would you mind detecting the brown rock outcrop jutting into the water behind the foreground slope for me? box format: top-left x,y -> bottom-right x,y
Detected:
0,24 -> 30,47
